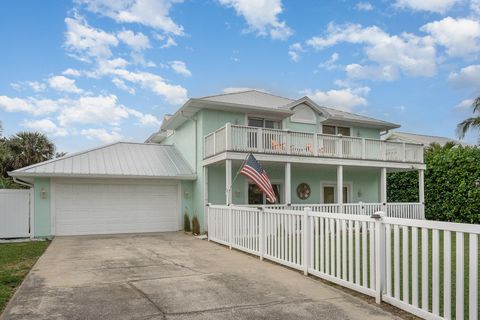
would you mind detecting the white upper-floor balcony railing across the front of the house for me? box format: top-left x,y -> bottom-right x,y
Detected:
203,123 -> 423,163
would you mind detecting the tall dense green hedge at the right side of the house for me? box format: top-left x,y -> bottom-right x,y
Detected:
387,146 -> 480,223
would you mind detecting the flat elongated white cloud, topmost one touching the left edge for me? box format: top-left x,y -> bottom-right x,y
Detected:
0,96 -> 59,116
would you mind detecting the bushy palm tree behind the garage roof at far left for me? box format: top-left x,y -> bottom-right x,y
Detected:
7,132 -> 55,169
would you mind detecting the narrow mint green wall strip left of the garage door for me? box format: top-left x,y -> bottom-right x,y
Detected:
34,178 -> 52,237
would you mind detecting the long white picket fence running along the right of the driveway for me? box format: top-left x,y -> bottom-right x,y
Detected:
207,205 -> 480,319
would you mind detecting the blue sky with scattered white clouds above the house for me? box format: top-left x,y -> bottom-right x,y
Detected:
0,0 -> 480,152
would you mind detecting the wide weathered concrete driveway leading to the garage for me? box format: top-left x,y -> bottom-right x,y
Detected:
3,233 -> 402,320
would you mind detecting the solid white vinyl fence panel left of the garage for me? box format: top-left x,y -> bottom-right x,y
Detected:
0,189 -> 33,239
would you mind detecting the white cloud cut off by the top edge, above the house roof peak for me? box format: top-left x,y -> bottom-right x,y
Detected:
219,0 -> 293,40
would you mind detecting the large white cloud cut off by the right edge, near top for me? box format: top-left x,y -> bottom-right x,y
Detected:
420,17 -> 480,59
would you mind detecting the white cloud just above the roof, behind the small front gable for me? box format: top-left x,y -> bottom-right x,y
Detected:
303,87 -> 370,111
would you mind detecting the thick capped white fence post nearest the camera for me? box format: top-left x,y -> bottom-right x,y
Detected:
370,212 -> 384,303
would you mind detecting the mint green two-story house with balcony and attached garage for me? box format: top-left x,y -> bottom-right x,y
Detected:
10,90 -> 425,236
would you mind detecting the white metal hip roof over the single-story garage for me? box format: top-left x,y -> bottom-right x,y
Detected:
9,142 -> 196,180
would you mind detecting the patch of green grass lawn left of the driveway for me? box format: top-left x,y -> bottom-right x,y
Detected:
0,241 -> 50,313
